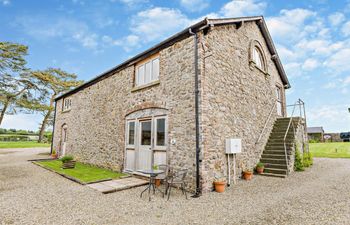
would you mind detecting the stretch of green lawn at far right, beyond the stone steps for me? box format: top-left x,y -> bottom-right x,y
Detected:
309,142 -> 350,158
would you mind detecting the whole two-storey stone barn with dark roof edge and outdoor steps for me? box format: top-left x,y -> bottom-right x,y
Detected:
53,16 -> 305,192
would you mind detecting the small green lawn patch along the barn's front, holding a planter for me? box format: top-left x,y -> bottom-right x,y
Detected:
36,160 -> 125,183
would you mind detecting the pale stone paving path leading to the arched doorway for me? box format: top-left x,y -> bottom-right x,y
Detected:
86,177 -> 148,194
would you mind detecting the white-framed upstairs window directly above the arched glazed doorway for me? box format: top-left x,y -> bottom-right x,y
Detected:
135,56 -> 159,86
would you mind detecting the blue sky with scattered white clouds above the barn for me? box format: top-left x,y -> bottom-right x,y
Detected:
0,0 -> 350,132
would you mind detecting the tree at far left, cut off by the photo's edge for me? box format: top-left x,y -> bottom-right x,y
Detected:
0,42 -> 35,125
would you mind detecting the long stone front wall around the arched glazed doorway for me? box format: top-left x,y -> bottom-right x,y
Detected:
53,37 -> 200,191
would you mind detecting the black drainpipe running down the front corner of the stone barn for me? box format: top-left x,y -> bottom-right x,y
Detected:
189,28 -> 201,198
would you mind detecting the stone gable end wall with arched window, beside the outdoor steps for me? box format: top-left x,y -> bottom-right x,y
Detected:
201,22 -> 285,191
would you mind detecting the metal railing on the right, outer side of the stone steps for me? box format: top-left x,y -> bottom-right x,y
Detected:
283,99 -> 307,175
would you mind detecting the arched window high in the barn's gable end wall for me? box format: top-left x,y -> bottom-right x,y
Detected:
249,40 -> 267,74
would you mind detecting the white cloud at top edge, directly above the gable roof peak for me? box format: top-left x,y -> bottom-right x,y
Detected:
220,0 -> 267,17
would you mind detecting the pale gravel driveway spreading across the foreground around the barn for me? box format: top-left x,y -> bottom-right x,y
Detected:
0,149 -> 350,224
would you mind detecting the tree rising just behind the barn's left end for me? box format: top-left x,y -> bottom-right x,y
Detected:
30,68 -> 83,142
